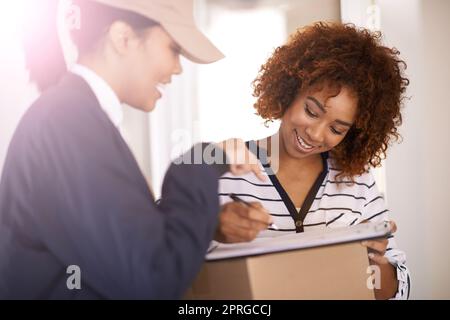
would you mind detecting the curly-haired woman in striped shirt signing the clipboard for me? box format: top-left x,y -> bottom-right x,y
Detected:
215,23 -> 409,299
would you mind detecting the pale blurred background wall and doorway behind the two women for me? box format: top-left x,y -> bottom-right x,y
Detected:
0,0 -> 450,299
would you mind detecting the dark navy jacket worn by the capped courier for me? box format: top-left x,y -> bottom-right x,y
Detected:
0,74 -> 226,299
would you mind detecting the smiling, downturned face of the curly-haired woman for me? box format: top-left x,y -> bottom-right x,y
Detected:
280,86 -> 358,158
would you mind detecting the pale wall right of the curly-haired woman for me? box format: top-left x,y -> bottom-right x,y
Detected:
342,0 -> 450,299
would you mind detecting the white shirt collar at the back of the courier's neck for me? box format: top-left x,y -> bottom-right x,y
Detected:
70,64 -> 123,131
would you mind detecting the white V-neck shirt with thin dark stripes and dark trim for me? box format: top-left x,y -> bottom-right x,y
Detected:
219,144 -> 410,299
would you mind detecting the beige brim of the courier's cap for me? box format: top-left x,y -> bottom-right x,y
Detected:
161,23 -> 225,64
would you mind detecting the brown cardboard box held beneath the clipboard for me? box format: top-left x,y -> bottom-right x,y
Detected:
185,242 -> 374,300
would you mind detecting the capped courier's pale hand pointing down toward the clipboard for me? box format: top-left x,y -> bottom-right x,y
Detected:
217,139 -> 267,182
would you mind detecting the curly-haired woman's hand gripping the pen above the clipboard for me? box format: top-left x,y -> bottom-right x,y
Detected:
214,202 -> 272,243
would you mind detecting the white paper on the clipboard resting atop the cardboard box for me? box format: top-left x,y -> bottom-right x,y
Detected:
206,222 -> 391,261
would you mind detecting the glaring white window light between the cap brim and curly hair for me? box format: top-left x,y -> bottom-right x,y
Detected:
198,7 -> 286,141
